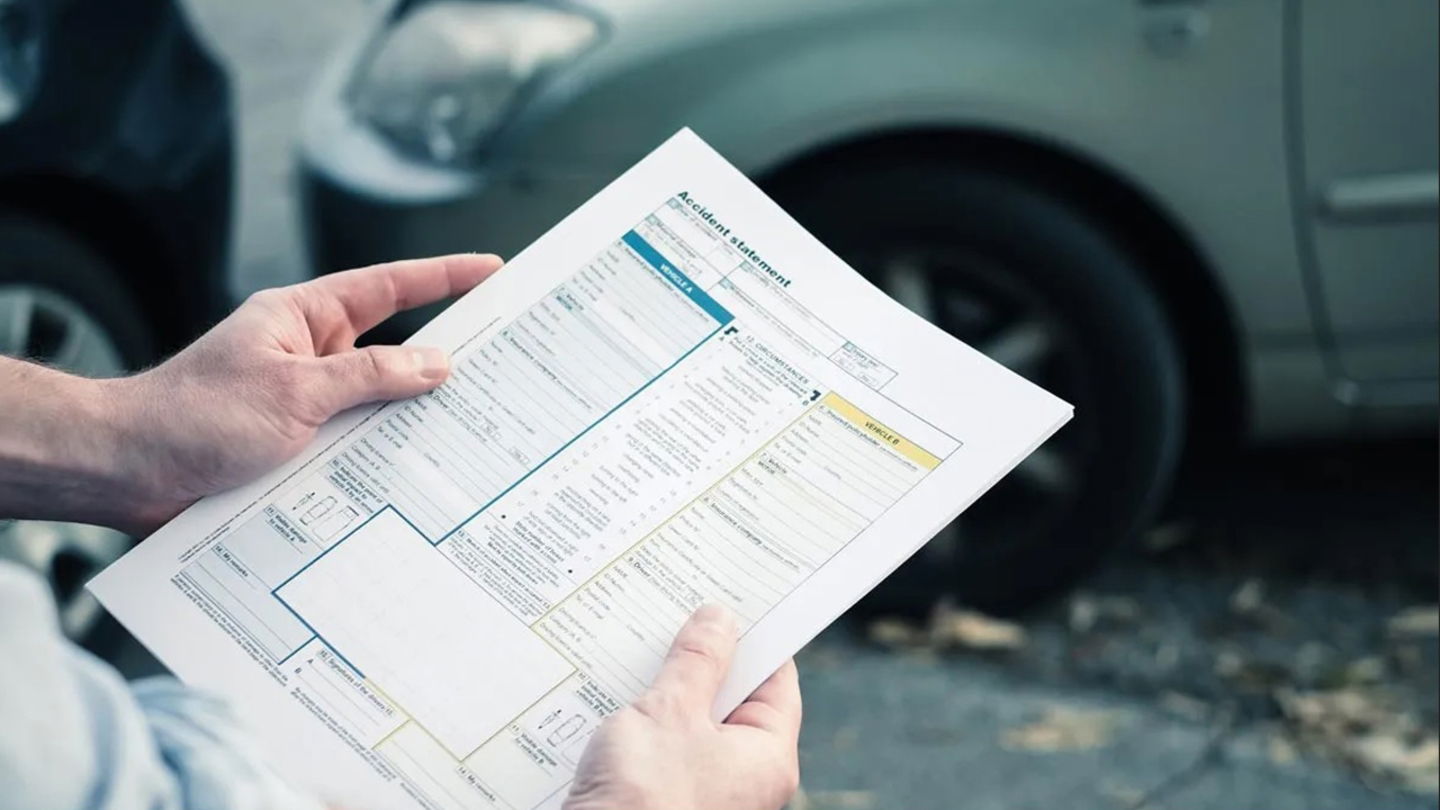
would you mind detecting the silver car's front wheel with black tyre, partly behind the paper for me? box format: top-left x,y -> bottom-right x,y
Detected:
773,161 -> 1184,613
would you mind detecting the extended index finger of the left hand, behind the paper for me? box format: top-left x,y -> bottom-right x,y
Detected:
305,254 -> 504,334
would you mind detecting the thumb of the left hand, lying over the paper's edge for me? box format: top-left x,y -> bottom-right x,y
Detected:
318,346 -> 449,414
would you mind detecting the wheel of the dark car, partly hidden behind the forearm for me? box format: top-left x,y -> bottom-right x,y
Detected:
0,210 -> 156,640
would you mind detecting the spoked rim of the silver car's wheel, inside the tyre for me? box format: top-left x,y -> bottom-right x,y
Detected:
857,245 -> 1097,561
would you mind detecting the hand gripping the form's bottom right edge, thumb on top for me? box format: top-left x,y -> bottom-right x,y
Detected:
564,605 -> 801,810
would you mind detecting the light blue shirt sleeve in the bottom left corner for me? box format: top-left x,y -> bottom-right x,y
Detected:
0,562 -> 321,810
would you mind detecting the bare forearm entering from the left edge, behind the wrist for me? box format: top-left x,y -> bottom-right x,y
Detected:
0,357 -> 157,532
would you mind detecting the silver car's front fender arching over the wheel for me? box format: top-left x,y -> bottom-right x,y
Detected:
507,0 -> 1338,432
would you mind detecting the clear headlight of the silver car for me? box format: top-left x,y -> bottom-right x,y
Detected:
347,0 -> 599,163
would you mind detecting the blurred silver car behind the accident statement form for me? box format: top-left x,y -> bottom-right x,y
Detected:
301,0 -> 1440,610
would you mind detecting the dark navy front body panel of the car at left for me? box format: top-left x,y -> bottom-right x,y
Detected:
0,0 -> 233,340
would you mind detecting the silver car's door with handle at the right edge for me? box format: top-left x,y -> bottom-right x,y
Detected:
1289,0 -> 1440,405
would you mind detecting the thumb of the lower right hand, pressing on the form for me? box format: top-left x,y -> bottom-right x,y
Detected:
641,604 -> 739,718
